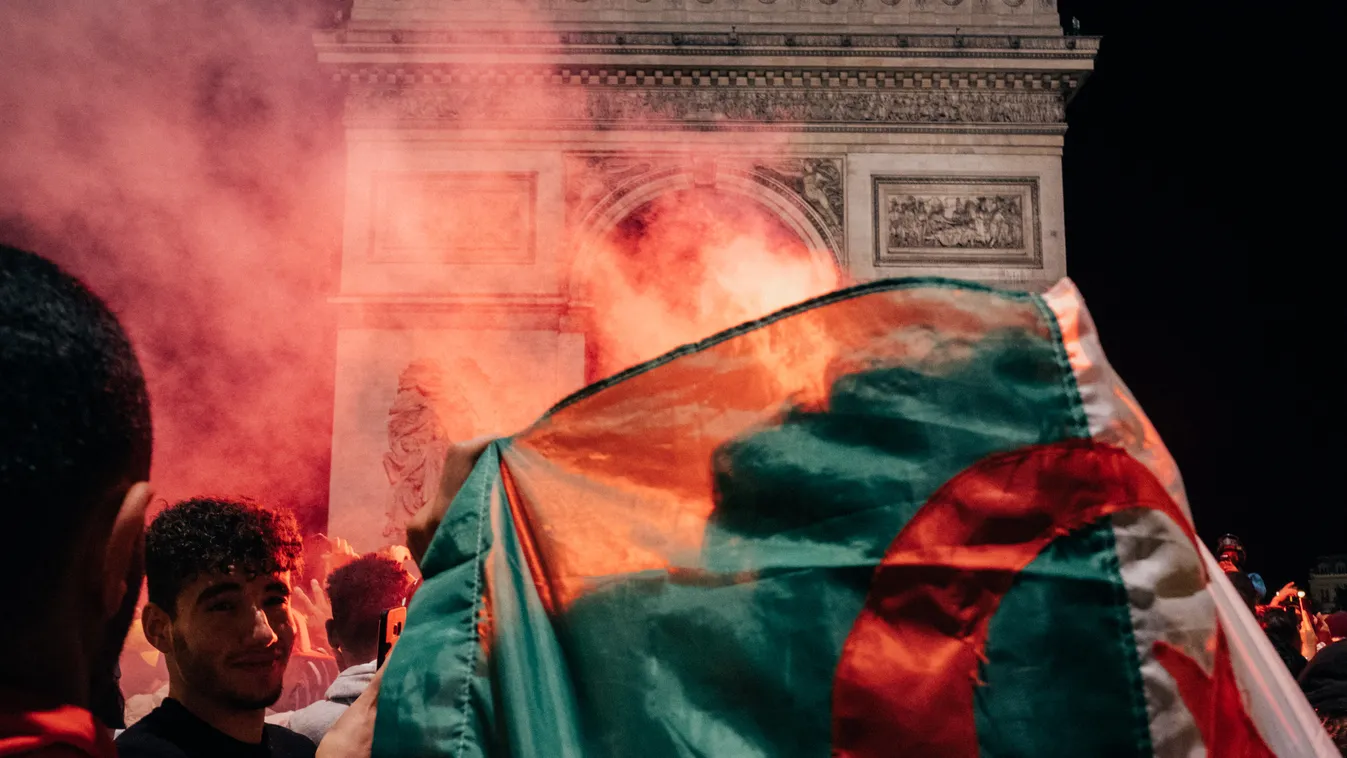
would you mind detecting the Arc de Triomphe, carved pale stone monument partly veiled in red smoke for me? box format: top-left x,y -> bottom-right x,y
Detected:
315,0 -> 1098,549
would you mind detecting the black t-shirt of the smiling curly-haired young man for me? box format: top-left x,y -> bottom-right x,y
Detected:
117,697 -> 318,758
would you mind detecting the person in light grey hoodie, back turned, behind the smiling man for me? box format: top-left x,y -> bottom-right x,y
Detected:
269,553 -> 412,742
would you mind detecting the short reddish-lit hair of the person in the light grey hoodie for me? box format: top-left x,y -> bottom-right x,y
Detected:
327,553 -> 412,650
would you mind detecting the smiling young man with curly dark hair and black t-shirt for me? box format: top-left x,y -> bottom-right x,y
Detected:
117,499 -> 315,758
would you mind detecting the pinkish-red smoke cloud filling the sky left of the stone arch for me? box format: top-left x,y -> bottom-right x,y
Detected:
0,1 -> 342,526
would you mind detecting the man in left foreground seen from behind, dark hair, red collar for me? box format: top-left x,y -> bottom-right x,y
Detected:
0,245 -> 152,758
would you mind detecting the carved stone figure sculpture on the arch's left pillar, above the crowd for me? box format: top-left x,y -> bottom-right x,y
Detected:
384,358 -> 490,537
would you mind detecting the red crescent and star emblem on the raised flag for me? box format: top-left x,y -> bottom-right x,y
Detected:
832,440 -> 1272,758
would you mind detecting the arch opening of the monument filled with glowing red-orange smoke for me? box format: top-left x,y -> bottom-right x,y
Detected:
571,175 -> 841,382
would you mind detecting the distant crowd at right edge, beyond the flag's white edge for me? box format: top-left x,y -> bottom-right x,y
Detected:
1216,535 -> 1347,755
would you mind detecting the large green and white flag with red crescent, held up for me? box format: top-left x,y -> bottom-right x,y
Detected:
374,280 -> 1335,758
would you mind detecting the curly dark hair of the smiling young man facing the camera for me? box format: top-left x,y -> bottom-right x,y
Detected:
145,498 -> 303,615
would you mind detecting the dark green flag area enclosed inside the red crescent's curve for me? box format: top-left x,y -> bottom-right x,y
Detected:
974,518 -> 1153,758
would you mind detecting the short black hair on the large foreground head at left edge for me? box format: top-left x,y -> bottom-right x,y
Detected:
0,245 -> 154,607
